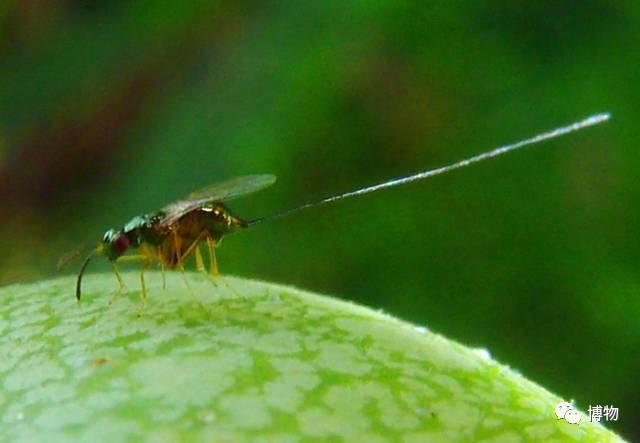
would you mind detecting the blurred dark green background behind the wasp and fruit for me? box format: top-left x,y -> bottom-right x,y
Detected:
0,0 -> 640,440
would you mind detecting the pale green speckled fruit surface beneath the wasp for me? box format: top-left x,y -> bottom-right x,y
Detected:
0,272 -> 621,442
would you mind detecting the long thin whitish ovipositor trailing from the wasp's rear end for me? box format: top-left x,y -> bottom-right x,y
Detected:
248,113 -> 611,227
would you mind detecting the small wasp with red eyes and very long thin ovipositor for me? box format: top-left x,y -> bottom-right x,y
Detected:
70,113 -> 610,300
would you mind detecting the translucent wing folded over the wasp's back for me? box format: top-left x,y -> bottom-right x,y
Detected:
159,174 -> 276,226
